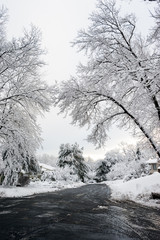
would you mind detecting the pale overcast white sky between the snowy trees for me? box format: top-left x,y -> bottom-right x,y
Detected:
0,0 -> 154,159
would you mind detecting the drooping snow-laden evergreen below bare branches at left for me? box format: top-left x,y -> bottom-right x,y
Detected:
1,101 -> 40,185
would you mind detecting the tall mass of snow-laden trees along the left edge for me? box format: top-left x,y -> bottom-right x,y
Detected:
0,8 -> 52,185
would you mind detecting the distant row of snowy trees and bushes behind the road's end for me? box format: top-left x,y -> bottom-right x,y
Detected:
38,143 -> 152,183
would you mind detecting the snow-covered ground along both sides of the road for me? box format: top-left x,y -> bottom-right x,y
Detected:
0,173 -> 160,207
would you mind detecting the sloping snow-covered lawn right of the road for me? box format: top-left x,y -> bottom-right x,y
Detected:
106,173 -> 160,207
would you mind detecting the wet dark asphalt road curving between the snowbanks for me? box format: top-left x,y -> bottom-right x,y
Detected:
0,184 -> 160,240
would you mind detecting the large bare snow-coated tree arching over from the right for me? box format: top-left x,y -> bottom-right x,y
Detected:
54,0 -> 160,157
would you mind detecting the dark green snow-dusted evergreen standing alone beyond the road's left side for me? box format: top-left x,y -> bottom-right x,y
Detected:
58,143 -> 87,182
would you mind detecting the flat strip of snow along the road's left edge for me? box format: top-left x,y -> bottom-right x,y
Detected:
0,181 -> 84,197
